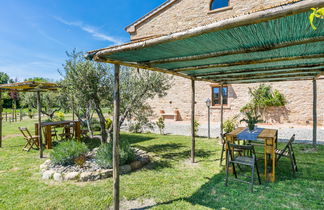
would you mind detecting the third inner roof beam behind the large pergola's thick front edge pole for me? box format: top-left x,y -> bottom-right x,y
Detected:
192,63 -> 324,78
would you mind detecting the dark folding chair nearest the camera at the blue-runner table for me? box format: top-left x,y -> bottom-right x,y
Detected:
225,142 -> 261,192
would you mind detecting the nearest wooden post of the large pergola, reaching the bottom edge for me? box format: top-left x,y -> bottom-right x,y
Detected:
113,64 -> 120,210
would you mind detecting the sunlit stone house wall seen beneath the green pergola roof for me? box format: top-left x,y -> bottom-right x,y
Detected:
150,77 -> 324,125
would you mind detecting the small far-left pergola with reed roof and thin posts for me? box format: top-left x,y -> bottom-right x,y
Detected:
0,81 -> 59,158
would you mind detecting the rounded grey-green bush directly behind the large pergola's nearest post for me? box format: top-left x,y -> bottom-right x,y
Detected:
96,140 -> 135,168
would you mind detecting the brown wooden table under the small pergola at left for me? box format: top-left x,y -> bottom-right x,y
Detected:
35,121 -> 81,149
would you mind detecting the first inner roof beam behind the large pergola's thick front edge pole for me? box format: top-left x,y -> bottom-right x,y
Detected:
142,36 -> 324,66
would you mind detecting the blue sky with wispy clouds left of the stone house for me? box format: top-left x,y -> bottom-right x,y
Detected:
0,0 -> 165,80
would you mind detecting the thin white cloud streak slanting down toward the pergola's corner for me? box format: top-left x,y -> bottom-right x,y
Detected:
54,17 -> 123,44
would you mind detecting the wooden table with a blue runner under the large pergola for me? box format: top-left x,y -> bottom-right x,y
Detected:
226,127 -> 278,182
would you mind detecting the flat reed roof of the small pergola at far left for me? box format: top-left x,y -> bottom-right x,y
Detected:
0,81 -> 59,92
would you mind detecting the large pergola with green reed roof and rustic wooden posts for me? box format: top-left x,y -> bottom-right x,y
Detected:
87,0 -> 324,209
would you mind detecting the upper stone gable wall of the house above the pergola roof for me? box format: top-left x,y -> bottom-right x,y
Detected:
130,0 -> 300,40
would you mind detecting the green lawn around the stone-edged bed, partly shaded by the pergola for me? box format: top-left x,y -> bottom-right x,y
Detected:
0,121 -> 324,209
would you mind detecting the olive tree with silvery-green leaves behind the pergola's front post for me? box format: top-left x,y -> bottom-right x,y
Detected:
61,51 -> 171,142
